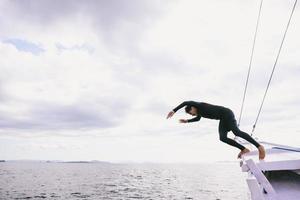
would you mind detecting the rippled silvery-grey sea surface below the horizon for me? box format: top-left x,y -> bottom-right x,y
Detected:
0,162 -> 250,200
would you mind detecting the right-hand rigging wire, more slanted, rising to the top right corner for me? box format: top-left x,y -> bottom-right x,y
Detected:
251,0 -> 298,136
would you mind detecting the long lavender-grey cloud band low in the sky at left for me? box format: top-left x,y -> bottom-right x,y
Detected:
0,96 -> 131,131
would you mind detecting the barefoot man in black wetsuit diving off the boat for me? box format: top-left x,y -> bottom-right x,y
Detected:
167,101 -> 265,159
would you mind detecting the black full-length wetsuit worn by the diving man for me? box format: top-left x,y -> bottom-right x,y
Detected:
173,101 -> 259,150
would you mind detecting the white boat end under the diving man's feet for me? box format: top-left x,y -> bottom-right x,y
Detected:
240,142 -> 300,200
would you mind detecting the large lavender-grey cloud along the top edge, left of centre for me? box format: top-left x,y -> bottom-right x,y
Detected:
0,0 -> 170,48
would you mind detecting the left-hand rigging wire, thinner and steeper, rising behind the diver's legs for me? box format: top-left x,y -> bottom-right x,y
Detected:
238,0 -> 263,126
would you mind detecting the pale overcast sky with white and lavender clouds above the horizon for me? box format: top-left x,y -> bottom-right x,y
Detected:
0,0 -> 300,163
